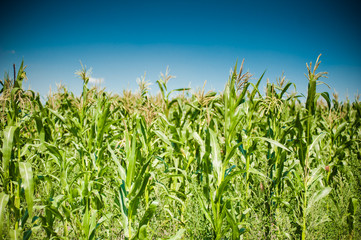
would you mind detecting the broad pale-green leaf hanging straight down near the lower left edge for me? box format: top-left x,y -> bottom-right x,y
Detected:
19,162 -> 34,216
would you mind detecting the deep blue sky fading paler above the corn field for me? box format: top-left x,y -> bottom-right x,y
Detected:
0,0 -> 361,100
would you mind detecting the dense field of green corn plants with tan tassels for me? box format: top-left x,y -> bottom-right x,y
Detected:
0,55 -> 361,240
